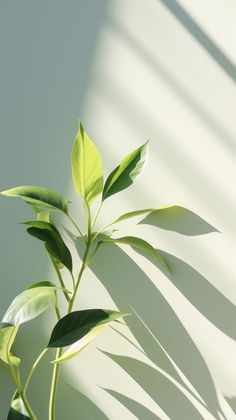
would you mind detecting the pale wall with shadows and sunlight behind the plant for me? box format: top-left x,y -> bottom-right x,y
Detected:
0,0 -> 236,420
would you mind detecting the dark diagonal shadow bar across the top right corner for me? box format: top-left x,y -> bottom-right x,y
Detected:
159,0 -> 236,82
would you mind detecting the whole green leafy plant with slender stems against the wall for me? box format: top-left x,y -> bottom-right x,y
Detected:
0,124 -> 171,420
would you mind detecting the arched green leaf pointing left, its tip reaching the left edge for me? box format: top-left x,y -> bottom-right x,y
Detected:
0,186 -> 68,214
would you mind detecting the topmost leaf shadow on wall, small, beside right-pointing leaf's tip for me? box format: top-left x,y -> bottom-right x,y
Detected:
138,206 -> 219,236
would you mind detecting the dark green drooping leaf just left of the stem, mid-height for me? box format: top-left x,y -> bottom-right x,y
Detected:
24,220 -> 72,271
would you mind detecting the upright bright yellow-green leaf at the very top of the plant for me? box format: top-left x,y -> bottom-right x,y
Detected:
71,124 -> 103,204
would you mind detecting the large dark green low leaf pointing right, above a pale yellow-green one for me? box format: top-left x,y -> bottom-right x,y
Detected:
48,309 -> 127,347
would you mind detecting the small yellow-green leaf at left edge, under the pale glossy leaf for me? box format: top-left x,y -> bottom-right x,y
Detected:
0,325 -> 20,367
